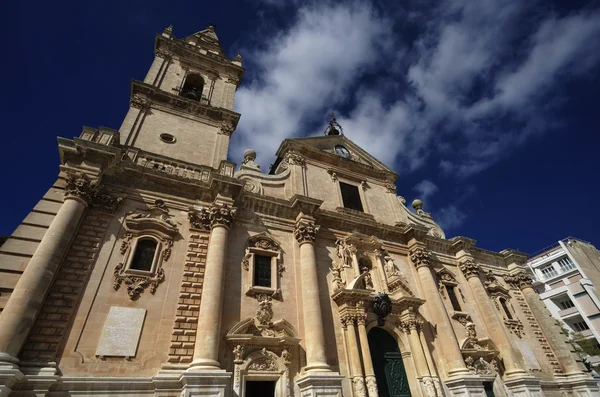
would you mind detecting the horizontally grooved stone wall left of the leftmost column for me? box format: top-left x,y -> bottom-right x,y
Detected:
0,179 -> 64,311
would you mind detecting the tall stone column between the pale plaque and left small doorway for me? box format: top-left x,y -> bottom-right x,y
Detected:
189,204 -> 235,371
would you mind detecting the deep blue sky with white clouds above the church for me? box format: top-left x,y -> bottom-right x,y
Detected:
0,0 -> 600,253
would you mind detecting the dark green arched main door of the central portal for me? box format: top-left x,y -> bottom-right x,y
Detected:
367,327 -> 410,397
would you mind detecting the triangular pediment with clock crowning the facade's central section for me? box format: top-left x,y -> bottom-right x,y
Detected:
277,135 -> 397,180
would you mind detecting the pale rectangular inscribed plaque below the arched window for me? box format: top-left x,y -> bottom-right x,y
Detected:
96,306 -> 146,357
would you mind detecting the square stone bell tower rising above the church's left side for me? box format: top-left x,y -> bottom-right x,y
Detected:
119,26 -> 244,169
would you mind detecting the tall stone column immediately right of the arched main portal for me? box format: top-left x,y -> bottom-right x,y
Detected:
409,246 -> 470,377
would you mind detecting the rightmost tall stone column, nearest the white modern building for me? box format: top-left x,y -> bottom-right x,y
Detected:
504,271 -> 583,376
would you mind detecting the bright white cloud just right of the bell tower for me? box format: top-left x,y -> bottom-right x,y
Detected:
231,2 -> 388,169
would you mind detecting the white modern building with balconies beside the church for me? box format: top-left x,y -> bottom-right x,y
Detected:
527,237 -> 600,369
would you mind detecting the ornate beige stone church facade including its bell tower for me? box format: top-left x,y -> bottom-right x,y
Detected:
0,27 -> 599,397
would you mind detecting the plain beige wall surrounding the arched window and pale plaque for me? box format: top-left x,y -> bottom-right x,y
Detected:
51,196 -> 195,377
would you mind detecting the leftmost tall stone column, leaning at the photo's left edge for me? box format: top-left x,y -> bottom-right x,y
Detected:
0,173 -> 97,363
